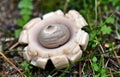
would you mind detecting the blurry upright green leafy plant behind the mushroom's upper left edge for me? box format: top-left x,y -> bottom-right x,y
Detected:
15,0 -> 33,38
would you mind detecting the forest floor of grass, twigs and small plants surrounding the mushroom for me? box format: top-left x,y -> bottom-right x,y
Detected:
0,0 -> 120,77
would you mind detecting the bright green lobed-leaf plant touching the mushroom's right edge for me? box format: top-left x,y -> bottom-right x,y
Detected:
86,15 -> 115,49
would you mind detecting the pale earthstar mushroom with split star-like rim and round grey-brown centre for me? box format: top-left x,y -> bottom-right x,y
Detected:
19,10 -> 89,69
